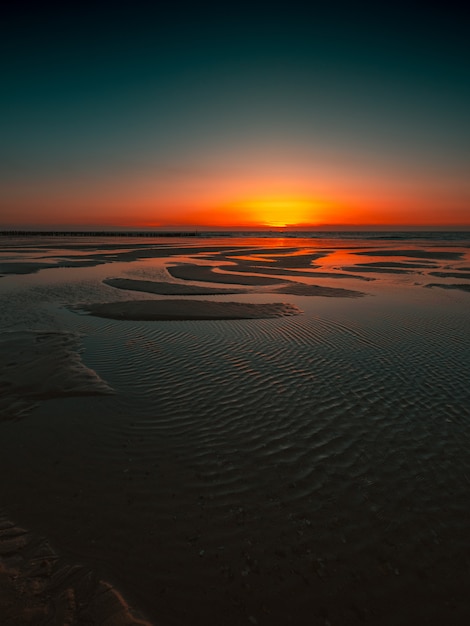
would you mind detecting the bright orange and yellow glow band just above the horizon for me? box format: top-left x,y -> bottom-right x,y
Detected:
2,172 -> 470,230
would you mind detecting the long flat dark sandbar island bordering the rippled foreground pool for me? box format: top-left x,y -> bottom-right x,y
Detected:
73,300 -> 301,321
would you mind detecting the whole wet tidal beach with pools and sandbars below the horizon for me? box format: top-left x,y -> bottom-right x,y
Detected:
0,233 -> 470,626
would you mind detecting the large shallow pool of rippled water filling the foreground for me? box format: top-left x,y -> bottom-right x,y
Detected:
0,236 -> 470,626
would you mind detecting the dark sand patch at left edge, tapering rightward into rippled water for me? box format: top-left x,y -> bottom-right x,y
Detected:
0,331 -> 112,419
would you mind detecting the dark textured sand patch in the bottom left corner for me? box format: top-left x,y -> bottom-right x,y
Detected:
0,520 -> 151,626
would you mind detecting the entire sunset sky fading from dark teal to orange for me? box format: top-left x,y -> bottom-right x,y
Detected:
0,2 -> 470,229
